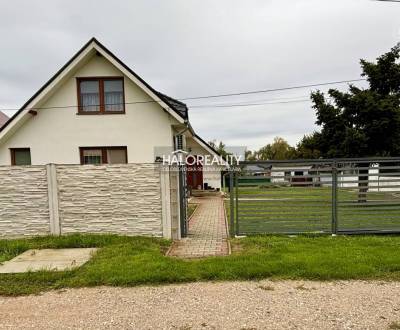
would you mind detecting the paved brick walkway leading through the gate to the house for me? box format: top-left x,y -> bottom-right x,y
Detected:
169,196 -> 228,258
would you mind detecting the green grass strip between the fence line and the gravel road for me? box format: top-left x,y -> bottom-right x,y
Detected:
0,235 -> 400,295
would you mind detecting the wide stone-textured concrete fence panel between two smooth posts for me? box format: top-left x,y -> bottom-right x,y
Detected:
57,164 -> 162,236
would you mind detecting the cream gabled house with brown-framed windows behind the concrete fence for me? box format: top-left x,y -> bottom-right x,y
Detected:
0,38 -> 221,189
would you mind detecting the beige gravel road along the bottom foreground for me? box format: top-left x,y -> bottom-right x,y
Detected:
0,281 -> 400,330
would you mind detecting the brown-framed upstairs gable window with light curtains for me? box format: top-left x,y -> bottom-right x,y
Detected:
78,77 -> 125,114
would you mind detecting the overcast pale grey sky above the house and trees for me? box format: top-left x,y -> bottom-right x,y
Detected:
0,0 -> 400,150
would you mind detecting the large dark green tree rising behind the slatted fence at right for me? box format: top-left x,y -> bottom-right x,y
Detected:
298,45 -> 400,158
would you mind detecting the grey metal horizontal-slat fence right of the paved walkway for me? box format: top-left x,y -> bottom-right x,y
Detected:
227,158 -> 400,235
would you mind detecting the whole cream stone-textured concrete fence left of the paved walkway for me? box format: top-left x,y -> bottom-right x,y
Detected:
0,164 -> 180,239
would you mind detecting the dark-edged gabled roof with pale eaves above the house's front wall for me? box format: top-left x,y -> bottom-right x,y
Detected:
0,37 -> 188,138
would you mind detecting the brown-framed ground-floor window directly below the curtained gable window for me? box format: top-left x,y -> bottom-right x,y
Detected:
79,147 -> 128,165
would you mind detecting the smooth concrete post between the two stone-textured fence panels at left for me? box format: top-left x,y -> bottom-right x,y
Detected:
46,164 -> 61,235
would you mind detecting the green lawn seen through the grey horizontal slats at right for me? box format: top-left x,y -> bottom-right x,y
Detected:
227,184 -> 400,235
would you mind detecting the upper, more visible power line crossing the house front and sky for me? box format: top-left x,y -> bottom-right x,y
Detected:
0,79 -> 366,111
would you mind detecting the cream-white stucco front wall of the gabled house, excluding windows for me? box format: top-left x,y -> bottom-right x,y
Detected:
0,55 -> 177,165
